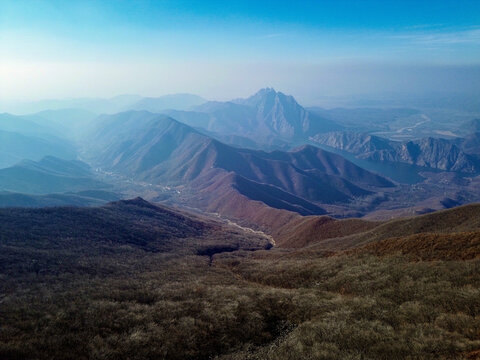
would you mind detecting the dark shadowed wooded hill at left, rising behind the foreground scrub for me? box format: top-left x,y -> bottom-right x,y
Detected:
0,198 -> 268,251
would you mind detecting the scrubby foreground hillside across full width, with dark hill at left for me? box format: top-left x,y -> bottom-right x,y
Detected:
0,199 -> 480,359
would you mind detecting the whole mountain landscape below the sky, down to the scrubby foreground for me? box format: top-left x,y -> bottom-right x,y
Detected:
0,88 -> 480,360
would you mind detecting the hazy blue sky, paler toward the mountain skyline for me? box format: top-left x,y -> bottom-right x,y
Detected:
0,0 -> 480,105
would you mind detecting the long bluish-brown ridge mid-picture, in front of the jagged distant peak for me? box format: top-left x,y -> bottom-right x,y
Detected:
88,112 -> 392,218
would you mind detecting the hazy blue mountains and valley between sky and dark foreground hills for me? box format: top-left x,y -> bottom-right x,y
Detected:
0,88 -> 480,224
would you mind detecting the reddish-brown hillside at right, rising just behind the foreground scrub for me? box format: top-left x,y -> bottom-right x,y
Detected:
274,204 -> 480,260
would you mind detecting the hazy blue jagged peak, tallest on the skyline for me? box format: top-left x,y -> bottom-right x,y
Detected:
166,88 -> 342,144
